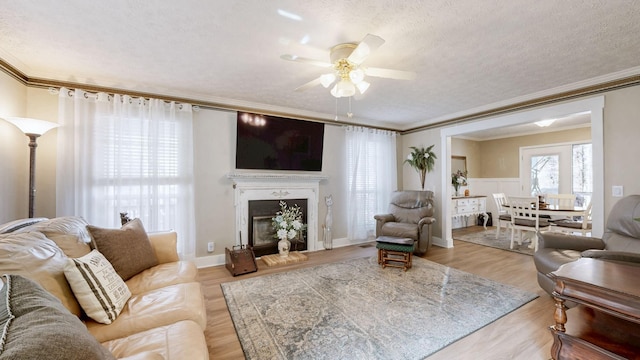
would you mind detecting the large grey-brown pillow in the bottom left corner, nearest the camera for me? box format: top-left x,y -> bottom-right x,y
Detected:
0,275 -> 115,360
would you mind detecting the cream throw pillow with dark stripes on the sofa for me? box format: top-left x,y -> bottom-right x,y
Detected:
64,250 -> 131,324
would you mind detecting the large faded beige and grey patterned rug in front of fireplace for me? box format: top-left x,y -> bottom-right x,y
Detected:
221,257 -> 537,360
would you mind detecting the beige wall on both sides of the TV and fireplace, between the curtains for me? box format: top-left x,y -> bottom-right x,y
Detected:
193,109 -> 347,257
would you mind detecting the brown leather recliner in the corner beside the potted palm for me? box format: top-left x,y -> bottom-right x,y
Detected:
374,190 -> 436,255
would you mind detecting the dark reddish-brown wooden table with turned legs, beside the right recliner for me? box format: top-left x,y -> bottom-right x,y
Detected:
550,258 -> 640,360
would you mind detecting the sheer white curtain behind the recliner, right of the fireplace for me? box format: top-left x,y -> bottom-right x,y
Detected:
345,126 -> 398,239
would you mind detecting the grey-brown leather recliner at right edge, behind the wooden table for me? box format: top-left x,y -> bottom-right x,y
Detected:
533,195 -> 640,294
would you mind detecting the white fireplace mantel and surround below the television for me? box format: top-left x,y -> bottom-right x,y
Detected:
227,172 -> 329,251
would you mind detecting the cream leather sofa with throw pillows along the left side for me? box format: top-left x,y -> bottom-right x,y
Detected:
0,218 -> 209,359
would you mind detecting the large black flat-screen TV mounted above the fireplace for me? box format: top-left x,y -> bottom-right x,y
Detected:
236,112 -> 324,171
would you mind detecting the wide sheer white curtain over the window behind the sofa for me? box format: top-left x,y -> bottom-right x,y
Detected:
56,88 -> 195,259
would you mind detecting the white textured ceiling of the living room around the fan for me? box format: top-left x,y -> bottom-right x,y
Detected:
0,0 -> 640,130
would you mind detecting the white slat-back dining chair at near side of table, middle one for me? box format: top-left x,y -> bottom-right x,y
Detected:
508,196 -> 550,252
